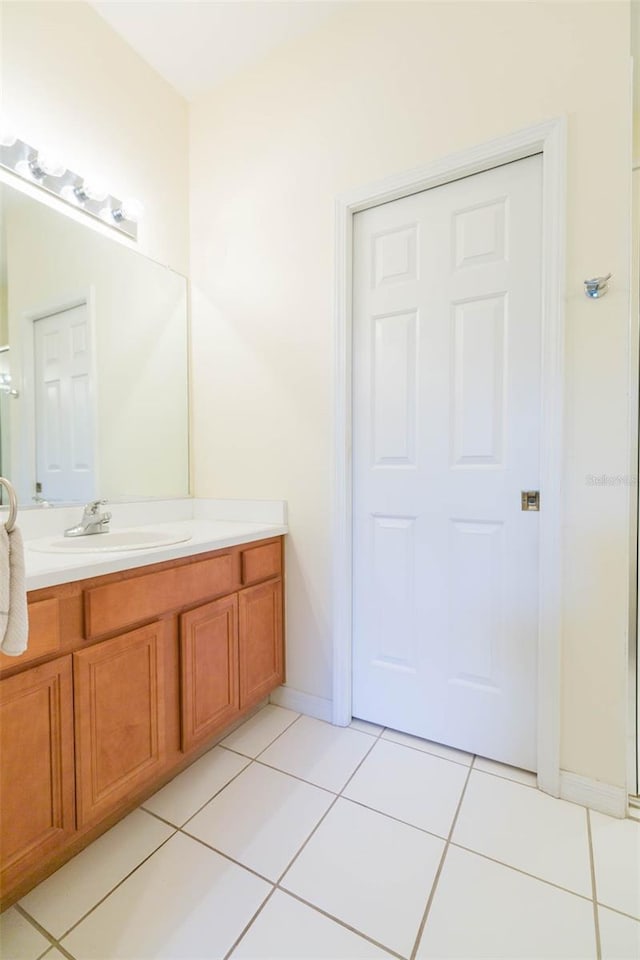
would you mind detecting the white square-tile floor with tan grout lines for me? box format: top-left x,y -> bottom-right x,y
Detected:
0,706 -> 640,960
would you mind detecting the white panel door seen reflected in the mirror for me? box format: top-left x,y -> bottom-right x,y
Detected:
34,303 -> 96,501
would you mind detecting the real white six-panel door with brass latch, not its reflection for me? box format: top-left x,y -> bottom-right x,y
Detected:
353,156 -> 544,770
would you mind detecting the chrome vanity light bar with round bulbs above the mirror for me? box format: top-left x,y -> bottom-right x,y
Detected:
0,136 -> 143,240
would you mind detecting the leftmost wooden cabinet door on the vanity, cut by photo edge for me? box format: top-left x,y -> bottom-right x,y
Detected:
0,656 -> 75,890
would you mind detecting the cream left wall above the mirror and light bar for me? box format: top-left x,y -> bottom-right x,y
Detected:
0,0 -> 189,274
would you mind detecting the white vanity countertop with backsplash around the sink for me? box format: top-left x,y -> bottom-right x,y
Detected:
14,499 -> 288,590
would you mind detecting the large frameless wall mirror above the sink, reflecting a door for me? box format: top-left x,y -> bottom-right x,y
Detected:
0,184 -> 189,505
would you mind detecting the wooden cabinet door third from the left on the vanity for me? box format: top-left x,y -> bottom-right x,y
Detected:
180,594 -> 239,752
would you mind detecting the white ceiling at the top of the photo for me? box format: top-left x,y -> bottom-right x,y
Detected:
89,0 -> 354,100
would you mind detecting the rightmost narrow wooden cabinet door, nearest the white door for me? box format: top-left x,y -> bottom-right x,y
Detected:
238,580 -> 284,708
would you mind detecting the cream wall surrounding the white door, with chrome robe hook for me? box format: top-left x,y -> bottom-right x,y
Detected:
190,2 -> 631,786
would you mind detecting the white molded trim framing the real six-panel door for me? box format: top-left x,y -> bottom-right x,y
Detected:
332,117 -> 566,796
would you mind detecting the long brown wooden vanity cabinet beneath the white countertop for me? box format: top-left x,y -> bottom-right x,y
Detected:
0,506 -> 286,906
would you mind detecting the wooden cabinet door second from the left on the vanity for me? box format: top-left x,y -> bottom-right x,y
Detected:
73,623 -> 165,826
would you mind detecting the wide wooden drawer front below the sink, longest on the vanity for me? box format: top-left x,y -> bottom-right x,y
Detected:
84,553 -> 237,639
